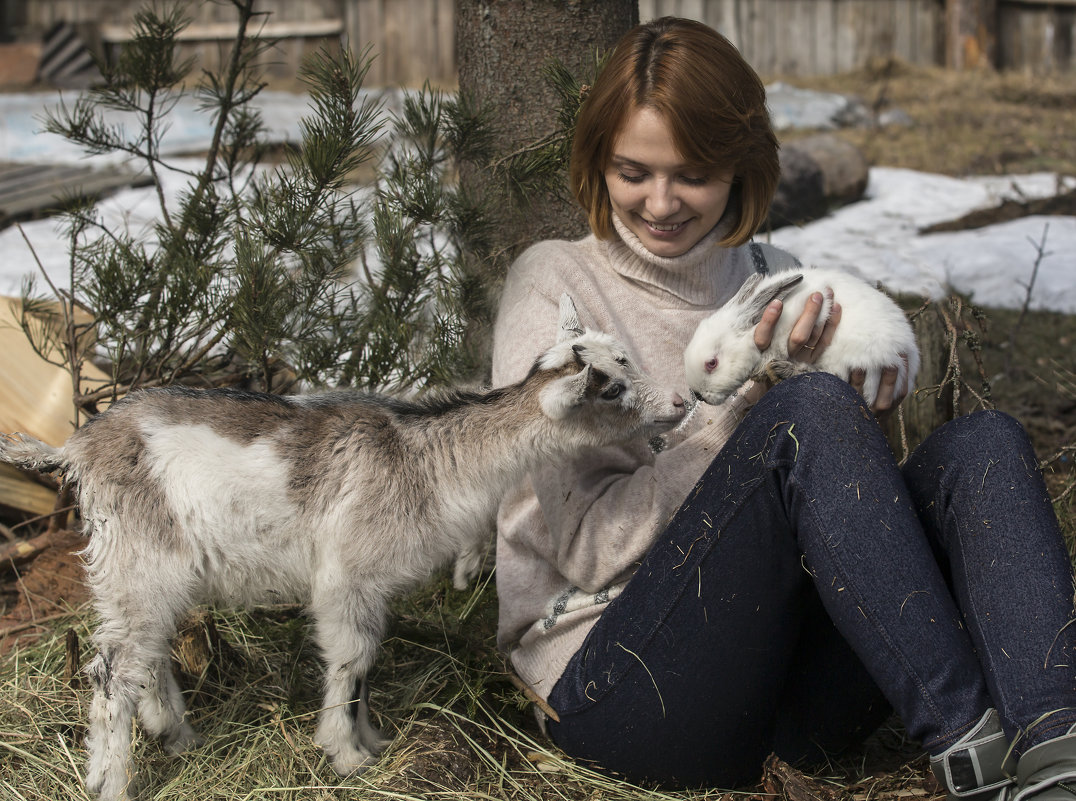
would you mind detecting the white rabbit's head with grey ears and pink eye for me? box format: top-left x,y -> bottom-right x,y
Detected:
683,272 -> 803,406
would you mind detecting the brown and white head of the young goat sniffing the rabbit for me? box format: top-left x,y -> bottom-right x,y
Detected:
533,295 -> 685,446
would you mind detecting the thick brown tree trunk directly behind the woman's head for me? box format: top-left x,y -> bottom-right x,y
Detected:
456,0 -> 639,258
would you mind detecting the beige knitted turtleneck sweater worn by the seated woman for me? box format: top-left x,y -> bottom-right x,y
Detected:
493,219 -> 797,698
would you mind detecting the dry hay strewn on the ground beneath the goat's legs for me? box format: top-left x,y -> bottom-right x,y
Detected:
0,577 -> 774,801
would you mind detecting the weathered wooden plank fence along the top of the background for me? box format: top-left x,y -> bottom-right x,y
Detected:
14,0 -> 1076,86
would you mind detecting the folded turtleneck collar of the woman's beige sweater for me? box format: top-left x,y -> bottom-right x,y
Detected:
608,212 -> 737,306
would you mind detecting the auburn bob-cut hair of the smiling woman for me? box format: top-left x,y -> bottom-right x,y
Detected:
569,17 -> 780,247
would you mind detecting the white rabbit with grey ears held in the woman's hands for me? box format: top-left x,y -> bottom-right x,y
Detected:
683,269 -> 919,405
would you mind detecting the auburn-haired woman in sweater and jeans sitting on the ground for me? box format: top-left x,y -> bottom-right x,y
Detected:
494,18 -> 1076,801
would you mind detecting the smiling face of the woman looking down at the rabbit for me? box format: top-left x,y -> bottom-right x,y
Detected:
605,107 -> 733,257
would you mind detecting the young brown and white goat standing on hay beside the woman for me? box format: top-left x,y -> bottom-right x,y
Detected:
0,296 -> 684,801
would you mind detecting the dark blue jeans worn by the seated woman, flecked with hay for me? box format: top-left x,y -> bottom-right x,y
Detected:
550,373 -> 1076,787
